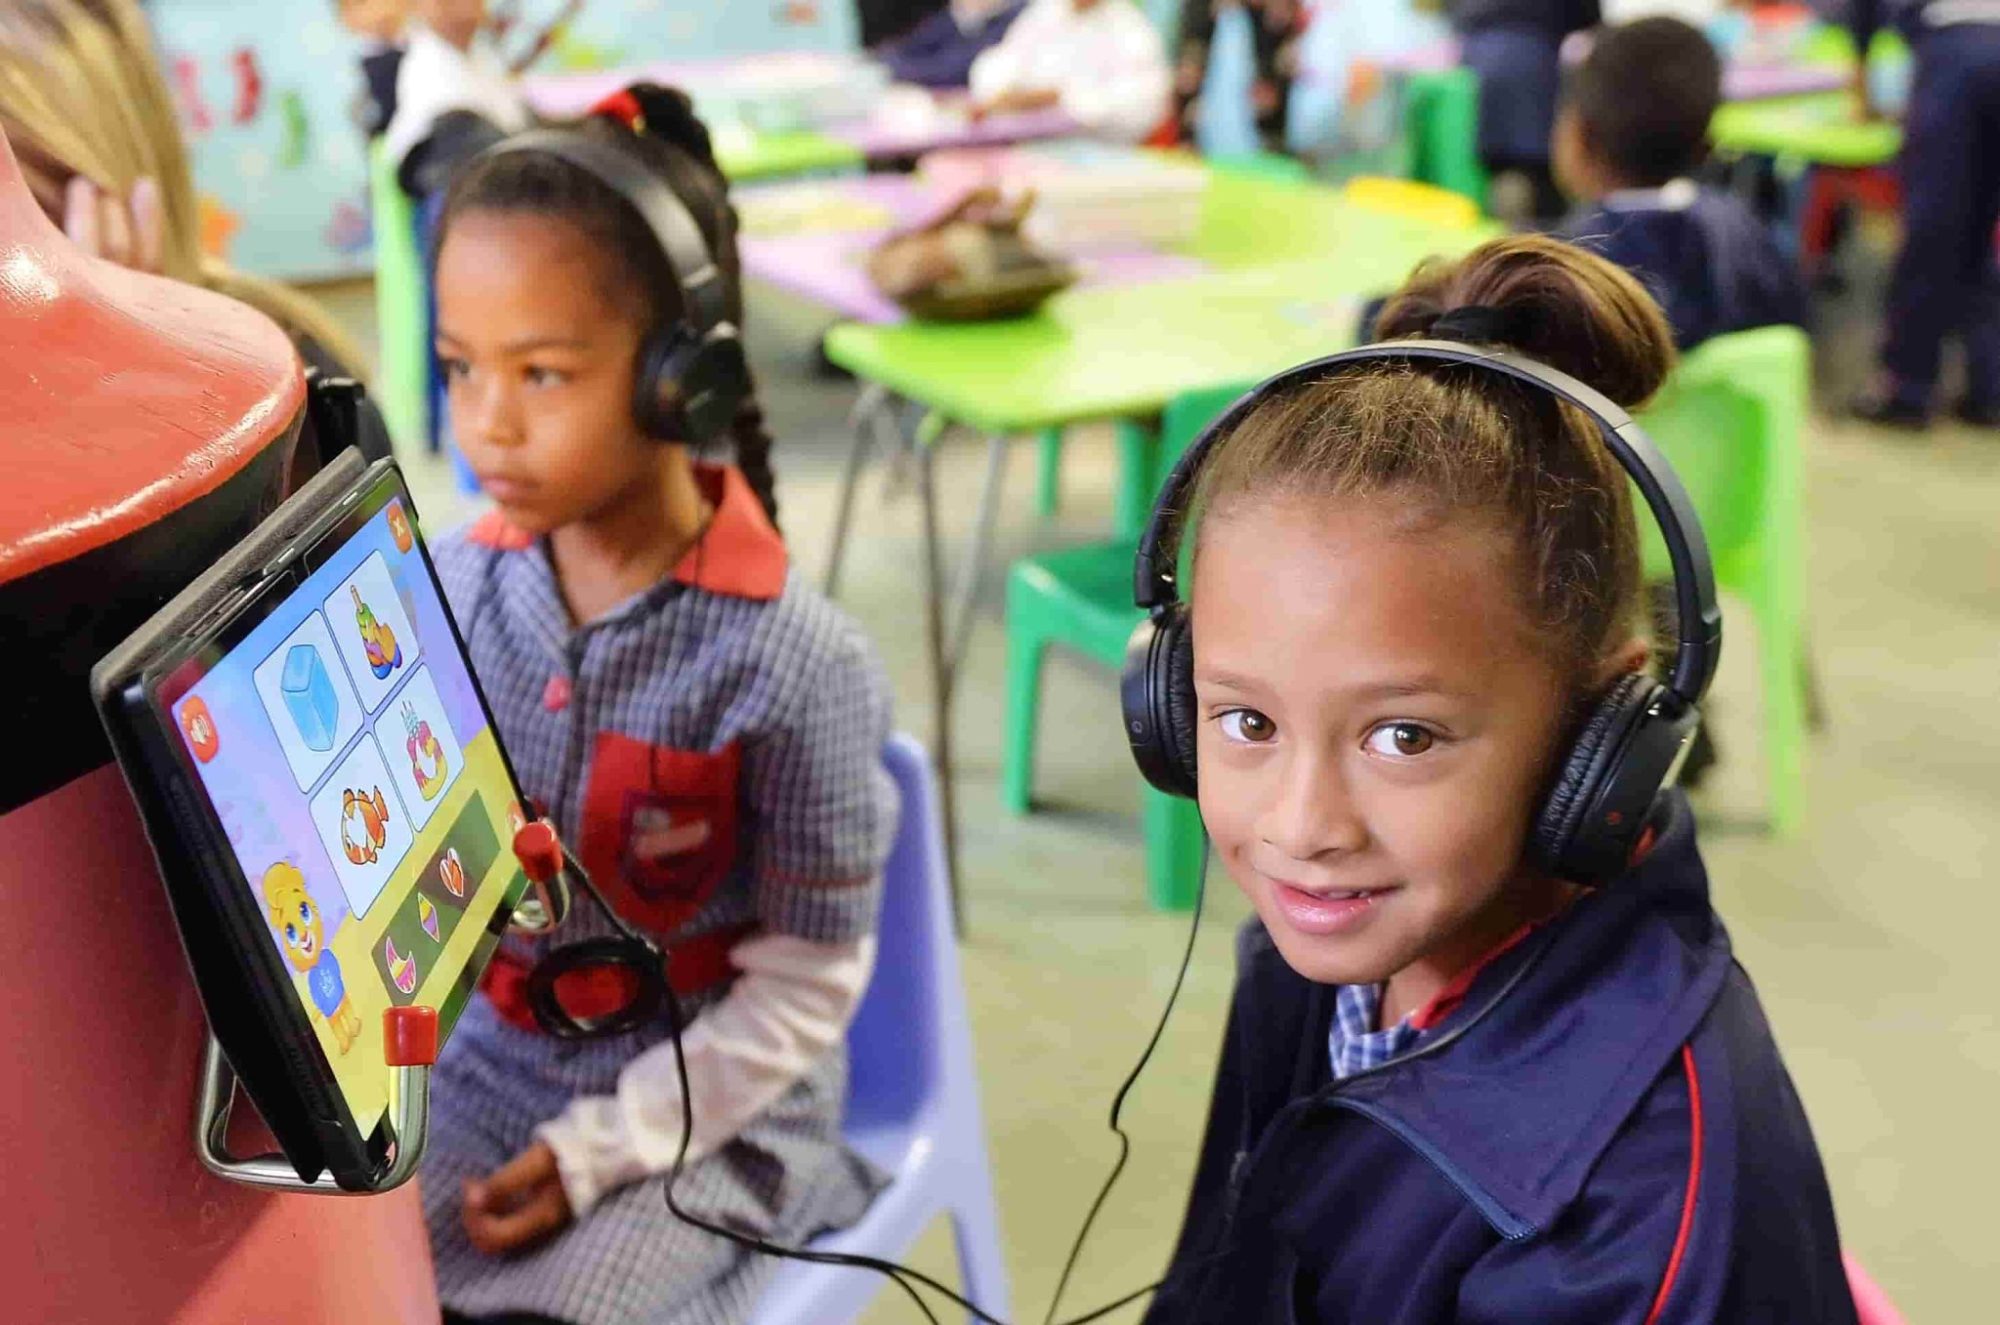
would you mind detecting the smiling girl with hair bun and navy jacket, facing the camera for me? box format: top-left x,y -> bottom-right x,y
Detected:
1128,236 -> 1854,1325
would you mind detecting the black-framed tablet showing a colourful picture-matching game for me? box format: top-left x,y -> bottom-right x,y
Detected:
92,452 -> 526,1189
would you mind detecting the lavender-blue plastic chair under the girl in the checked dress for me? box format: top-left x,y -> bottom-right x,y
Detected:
754,737 -> 1008,1325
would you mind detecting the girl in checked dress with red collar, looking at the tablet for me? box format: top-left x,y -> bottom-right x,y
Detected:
422,88 -> 896,1325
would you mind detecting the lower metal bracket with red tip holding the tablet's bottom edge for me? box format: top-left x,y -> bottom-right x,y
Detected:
194,1007 -> 438,1197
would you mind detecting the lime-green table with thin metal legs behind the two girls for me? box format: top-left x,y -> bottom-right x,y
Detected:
826,200 -> 1498,904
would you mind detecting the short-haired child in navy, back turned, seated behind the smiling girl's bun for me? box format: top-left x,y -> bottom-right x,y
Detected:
1552,18 -> 1806,350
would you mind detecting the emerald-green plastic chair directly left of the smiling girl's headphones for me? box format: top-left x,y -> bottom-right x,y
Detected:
1000,382 -> 1252,911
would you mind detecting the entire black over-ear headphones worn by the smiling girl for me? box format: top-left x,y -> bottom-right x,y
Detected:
1120,340 -> 1722,885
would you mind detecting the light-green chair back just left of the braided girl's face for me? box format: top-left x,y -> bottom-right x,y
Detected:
368,140 -> 430,450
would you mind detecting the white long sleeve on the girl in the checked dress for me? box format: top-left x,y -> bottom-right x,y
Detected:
536,935 -> 876,1217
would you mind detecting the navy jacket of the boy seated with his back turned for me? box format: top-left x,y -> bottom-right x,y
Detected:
1564,180 -> 1806,350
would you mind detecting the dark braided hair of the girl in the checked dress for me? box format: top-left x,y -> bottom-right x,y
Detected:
430,84 -> 778,524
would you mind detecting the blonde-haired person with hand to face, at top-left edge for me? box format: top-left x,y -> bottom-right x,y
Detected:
0,0 -> 362,374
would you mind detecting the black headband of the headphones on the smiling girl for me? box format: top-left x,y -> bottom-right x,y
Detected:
1132,340 -> 1722,705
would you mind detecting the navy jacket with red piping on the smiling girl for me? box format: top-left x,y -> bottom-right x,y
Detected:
1146,793 -> 1854,1325
